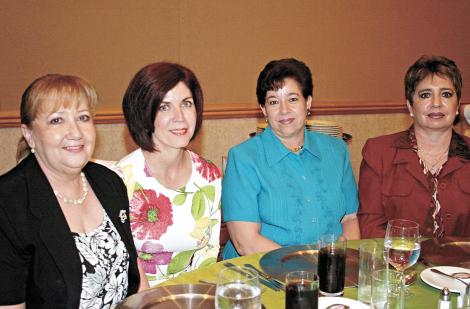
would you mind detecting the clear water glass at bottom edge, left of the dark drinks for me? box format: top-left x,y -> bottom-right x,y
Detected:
215,266 -> 261,309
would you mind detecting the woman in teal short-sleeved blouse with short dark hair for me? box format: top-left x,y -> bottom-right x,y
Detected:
222,59 -> 360,259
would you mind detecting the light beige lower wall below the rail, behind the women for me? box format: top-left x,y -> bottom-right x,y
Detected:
0,114 -> 410,178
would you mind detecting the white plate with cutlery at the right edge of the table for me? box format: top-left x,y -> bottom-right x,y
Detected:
420,266 -> 470,293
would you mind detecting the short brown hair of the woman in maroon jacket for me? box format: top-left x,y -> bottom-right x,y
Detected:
405,55 -> 462,105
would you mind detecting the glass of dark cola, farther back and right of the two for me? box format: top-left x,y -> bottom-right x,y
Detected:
318,234 -> 346,296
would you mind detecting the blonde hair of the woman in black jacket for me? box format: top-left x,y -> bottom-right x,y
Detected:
16,74 -> 98,162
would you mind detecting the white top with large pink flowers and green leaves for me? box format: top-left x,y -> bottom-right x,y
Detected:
113,149 -> 221,286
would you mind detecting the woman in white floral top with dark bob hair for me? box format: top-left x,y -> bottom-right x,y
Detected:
115,62 -> 221,286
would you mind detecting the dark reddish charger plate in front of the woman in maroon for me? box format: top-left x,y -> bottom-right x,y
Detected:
421,237 -> 470,268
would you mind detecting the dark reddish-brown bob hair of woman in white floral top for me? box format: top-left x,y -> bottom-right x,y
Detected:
122,62 -> 204,151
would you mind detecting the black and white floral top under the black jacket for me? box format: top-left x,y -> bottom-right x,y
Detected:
73,212 -> 129,309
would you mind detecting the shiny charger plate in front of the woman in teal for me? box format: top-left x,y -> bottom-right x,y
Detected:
259,245 -> 359,287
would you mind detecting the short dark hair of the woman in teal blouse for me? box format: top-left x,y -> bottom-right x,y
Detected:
256,58 -> 313,106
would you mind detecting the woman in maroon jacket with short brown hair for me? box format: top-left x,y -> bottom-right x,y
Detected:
358,56 -> 470,237
